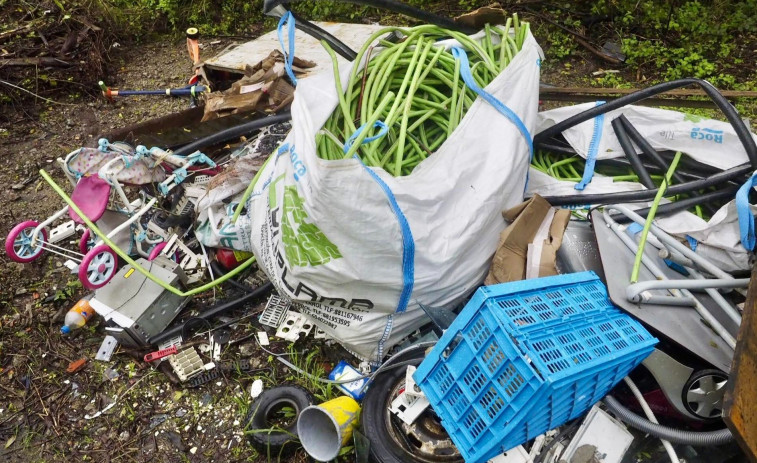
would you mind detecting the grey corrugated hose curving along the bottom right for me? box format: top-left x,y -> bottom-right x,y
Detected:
604,395 -> 733,447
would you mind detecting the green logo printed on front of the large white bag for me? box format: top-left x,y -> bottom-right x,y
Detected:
281,186 -> 342,267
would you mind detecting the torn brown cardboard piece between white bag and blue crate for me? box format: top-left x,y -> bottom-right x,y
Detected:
484,195 -> 570,285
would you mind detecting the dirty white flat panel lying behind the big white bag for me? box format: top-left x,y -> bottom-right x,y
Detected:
203,22 -> 384,78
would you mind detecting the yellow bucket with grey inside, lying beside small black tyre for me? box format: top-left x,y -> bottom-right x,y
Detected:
297,396 -> 360,461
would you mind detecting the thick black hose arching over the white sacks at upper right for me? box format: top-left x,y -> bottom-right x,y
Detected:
534,78 -> 757,170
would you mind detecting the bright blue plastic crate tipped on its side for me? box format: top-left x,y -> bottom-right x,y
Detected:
414,272 -> 657,463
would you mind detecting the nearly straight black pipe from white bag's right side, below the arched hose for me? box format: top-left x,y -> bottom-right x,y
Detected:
544,163 -> 754,206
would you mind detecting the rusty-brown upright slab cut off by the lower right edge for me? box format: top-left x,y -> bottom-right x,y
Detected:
723,267 -> 757,463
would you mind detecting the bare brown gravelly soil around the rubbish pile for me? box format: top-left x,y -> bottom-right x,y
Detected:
0,24 -> 748,462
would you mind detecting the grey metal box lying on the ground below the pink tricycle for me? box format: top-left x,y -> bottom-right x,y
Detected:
90,257 -> 190,347
